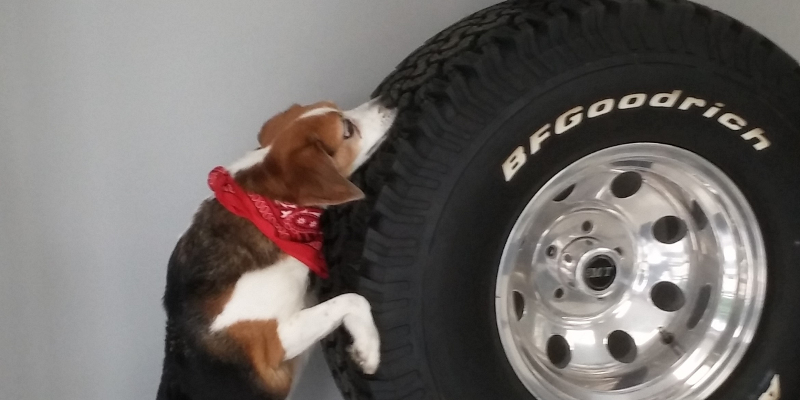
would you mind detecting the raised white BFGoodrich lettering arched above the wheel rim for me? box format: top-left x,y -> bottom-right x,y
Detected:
502,90 -> 772,182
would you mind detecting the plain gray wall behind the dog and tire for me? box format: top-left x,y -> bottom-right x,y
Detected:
0,0 -> 800,400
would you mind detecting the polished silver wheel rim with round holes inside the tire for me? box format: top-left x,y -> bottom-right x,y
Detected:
495,143 -> 767,400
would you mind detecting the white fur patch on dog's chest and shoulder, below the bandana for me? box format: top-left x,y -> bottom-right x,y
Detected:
210,257 -> 309,331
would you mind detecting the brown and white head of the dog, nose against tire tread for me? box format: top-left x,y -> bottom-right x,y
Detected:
231,99 -> 395,206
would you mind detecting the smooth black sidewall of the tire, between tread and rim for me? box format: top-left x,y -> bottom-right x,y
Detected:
415,57 -> 800,400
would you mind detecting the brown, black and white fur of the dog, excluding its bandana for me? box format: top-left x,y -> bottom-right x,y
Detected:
157,100 -> 394,400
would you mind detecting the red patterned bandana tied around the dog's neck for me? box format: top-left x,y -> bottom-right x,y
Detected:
208,167 -> 328,278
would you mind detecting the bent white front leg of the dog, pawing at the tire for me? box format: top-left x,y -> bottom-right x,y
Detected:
278,293 -> 380,374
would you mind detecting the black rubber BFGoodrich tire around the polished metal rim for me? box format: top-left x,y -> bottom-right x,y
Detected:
318,0 -> 800,400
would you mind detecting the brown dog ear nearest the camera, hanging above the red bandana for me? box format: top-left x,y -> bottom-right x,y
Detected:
290,141 -> 364,206
